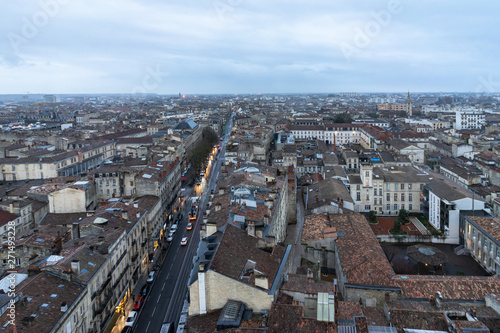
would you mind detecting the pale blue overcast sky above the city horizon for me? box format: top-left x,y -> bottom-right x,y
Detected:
0,0 -> 500,94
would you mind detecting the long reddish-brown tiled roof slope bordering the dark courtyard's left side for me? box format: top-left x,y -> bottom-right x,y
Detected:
330,214 -> 396,287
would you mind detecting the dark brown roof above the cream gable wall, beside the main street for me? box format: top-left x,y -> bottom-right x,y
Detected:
209,225 -> 284,290
